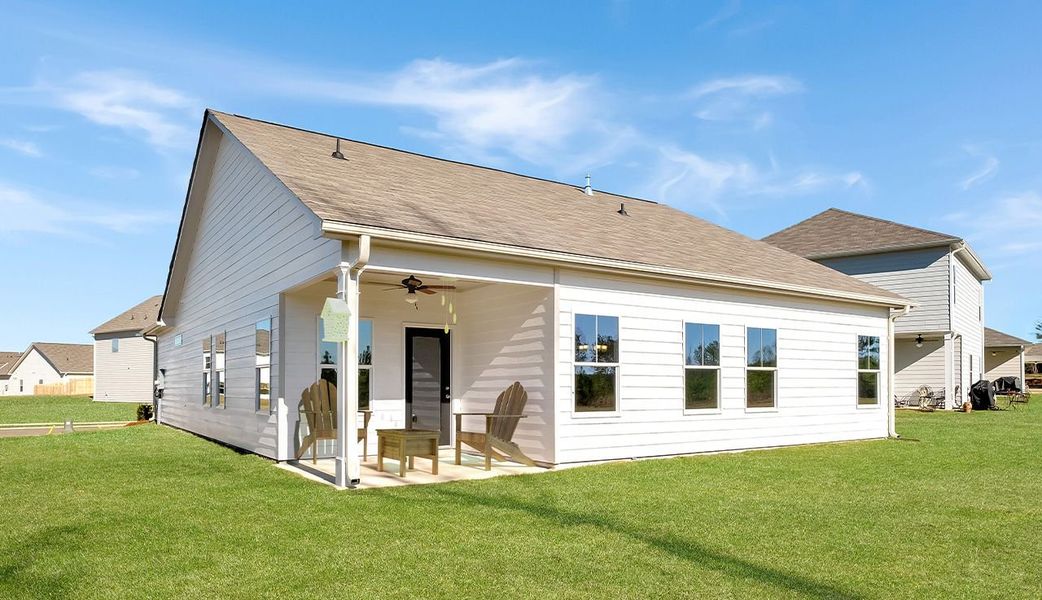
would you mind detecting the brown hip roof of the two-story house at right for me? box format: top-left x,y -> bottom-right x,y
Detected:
764,208 -> 961,258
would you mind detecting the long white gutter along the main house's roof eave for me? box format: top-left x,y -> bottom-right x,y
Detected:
322,221 -> 916,308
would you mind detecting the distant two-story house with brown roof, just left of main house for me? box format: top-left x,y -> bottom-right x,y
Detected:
91,296 -> 163,404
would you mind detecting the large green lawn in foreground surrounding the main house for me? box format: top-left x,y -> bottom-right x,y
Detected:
0,397 -> 1042,599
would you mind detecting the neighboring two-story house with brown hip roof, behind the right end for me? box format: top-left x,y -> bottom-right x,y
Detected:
764,208 -> 991,407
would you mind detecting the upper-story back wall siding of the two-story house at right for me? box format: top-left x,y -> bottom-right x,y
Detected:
820,247 -> 951,333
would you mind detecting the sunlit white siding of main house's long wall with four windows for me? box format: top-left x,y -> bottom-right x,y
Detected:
556,272 -> 887,463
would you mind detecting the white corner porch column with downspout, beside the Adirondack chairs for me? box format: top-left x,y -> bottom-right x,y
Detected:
336,264 -> 362,488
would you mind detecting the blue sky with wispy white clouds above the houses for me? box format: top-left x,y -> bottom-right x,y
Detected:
0,0 -> 1042,350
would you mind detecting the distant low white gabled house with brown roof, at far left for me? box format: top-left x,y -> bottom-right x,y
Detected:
0,342 -> 94,396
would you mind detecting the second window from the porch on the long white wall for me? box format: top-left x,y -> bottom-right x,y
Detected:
684,323 -> 720,410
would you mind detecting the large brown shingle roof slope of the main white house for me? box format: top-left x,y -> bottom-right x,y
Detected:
210,111 -> 907,305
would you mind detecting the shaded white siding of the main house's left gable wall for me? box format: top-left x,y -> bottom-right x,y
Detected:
159,132 -> 341,457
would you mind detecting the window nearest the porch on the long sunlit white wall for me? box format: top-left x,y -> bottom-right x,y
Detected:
574,315 -> 619,413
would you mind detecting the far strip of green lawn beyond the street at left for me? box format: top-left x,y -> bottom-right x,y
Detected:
0,396 -> 138,425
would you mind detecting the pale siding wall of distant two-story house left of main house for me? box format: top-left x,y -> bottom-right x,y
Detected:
94,334 -> 154,404
